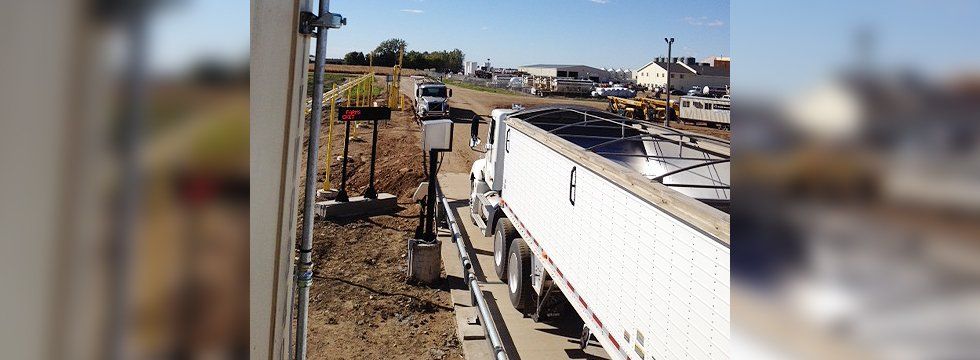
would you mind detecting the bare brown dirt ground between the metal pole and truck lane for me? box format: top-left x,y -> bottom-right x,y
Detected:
296,83 -> 462,359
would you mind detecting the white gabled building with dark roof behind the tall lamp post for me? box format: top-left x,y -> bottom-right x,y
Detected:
633,57 -> 730,89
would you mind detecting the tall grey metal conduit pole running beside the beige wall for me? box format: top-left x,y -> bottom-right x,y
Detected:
295,0 -> 330,360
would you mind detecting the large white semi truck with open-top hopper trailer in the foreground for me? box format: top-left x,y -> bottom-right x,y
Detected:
470,107 -> 731,359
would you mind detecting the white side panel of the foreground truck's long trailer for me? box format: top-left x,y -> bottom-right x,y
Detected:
502,130 -> 731,359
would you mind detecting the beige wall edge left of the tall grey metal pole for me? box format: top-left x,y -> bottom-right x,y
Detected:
249,0 -> 311,359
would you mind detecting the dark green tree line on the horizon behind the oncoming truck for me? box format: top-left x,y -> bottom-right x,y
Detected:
344,39 -> 466,72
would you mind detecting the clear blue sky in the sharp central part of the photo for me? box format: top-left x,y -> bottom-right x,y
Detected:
327,0 -> 729,69
